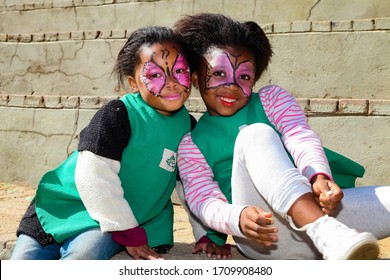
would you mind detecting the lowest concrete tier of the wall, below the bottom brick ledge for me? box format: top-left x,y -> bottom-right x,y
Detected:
0,95 -> 390,185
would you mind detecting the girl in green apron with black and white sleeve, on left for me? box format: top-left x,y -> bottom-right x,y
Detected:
12,27 -> 192,259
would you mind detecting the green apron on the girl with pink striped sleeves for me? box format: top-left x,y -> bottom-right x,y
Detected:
191,94 -> 364,245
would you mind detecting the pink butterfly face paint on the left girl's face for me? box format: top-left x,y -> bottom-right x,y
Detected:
140,49 -> 191,96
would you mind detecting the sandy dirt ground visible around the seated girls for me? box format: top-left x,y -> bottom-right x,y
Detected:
0,182 -> 390,259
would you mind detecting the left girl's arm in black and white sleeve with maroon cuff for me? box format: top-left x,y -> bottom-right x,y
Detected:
75,100 -> 160,259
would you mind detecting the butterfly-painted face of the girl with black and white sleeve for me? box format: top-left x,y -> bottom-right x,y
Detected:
128,42 -> 191,115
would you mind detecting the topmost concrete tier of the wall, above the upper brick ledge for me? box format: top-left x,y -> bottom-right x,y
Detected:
0,0 -> 390,33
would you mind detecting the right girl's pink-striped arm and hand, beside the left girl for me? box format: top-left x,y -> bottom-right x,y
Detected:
178,134 -> 277,249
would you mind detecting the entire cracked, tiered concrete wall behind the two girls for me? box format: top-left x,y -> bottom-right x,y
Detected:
0,0 -> 390,188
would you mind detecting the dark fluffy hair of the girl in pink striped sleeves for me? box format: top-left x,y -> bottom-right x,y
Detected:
172,13 -> 272,81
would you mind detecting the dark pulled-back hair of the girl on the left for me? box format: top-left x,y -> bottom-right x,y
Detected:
112,26 -> 189,86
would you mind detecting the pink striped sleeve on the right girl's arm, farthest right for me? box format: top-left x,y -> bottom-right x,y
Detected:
259,85 -> 332,180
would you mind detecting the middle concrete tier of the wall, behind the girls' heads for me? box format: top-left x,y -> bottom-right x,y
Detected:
0,18 -> 390,99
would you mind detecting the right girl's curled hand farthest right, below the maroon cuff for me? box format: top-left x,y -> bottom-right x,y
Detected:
311,174 -> 344,215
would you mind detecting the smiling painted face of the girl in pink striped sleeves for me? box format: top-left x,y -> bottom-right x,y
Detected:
193,47 -> 255,116
